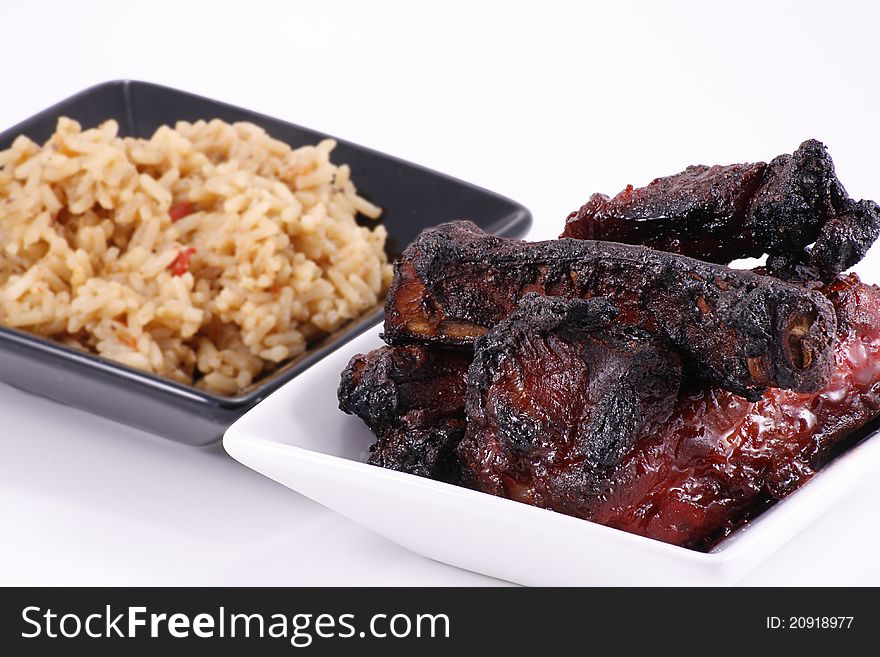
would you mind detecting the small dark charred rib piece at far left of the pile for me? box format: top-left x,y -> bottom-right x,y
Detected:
338,345 -> 471,483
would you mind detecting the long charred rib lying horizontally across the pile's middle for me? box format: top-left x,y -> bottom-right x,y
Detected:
385,221 -> 835,400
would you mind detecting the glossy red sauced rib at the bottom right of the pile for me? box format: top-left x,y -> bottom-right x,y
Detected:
458,275 -> 880,547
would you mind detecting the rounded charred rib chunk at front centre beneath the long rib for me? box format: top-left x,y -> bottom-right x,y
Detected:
465,294 -> 681,474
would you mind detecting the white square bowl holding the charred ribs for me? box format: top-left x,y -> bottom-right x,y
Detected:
223,328 -> 880,586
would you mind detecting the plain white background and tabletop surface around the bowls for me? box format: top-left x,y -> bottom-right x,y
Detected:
0,0 -> 880,585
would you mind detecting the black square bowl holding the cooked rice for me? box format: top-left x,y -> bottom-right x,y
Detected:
0,80 -> 531,445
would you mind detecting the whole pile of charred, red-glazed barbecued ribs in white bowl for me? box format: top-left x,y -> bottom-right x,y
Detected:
339,140 -> 880,550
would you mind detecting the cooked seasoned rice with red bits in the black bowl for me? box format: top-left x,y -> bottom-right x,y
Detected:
0,118 -> 391,394
